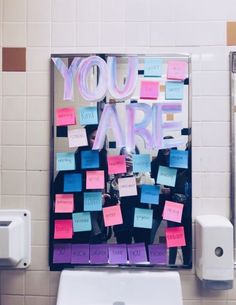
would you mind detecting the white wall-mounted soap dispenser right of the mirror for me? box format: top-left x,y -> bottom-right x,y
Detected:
196,215 -> 234,289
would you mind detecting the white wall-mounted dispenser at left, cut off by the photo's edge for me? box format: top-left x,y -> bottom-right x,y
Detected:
0,210 -> 31,269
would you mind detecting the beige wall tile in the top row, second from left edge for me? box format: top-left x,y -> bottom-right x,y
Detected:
27,0 -> 51,22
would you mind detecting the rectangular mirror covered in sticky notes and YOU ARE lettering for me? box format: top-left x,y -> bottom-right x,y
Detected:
49,54 -> 192,270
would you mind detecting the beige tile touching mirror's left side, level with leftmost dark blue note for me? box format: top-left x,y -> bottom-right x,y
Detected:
26,171 -> 49,196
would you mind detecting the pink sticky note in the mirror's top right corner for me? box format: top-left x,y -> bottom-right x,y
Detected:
167,60 -> 188,80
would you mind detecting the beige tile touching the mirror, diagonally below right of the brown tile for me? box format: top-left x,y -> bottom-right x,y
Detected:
27,72 -> 50,96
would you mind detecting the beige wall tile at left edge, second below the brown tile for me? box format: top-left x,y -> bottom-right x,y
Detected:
2,96 -> 26,121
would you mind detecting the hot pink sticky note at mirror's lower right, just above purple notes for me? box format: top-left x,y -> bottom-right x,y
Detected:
166,227 -> 186,248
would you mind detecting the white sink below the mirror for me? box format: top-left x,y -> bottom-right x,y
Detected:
56,269 -> 183,305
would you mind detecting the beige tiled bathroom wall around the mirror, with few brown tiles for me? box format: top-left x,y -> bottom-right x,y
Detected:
0,0 -> 236,305
